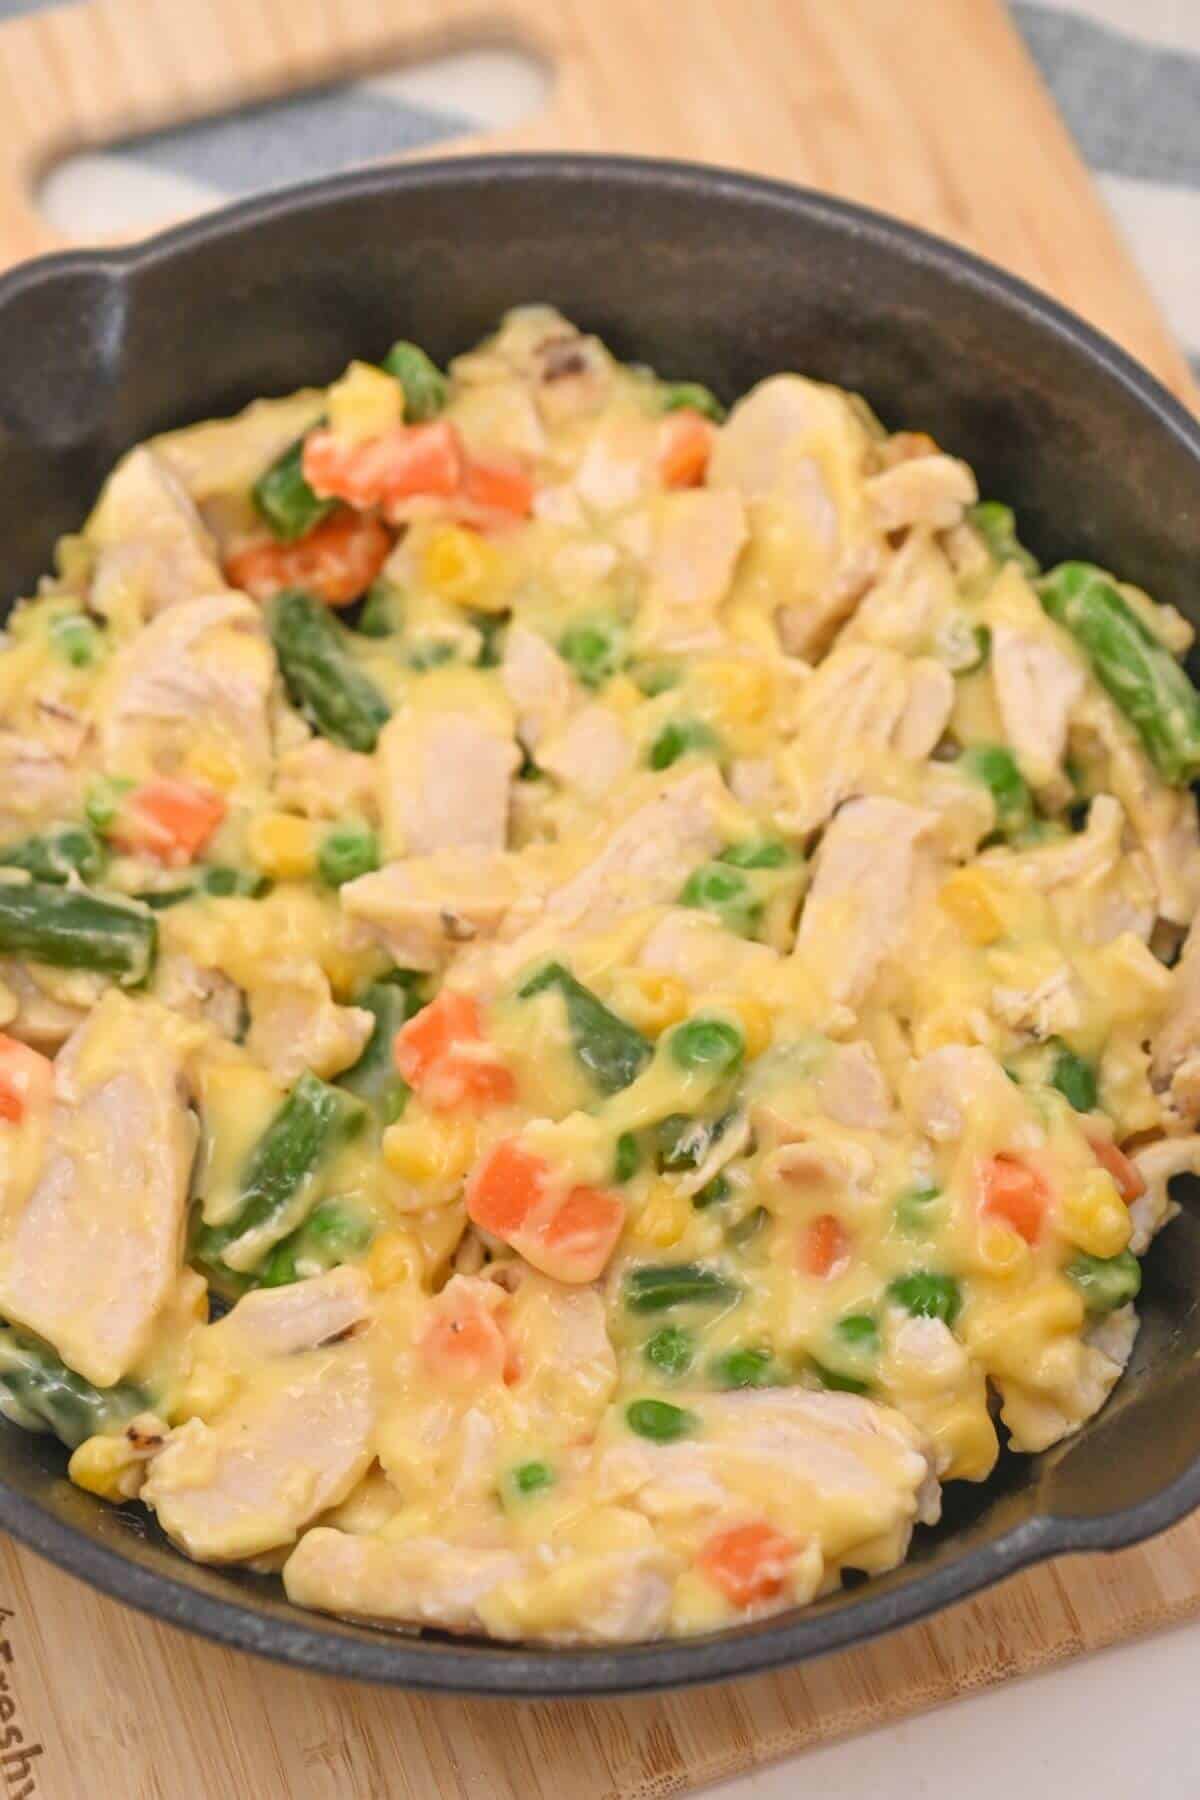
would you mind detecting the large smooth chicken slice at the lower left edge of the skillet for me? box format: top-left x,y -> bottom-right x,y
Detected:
0,990 -> 196,1388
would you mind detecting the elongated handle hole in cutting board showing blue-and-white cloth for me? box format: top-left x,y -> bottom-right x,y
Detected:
36,43 -> 552,241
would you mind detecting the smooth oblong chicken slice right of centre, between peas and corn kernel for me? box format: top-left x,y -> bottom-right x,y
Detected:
793,797 -> 936,1008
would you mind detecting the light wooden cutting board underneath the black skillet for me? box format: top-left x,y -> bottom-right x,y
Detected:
0,0 -> 1200,1800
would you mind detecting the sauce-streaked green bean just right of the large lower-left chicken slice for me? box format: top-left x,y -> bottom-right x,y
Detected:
198,1069 -> 363,1262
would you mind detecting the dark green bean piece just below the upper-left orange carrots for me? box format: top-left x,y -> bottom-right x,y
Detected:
268,589 -> 390,751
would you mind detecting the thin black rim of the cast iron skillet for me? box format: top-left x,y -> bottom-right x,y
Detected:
0,151 -> 1200,1699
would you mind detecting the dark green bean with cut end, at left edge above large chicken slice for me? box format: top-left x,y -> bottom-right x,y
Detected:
0,882 -> 158,988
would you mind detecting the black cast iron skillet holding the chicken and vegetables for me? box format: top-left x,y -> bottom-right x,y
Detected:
0,157 -> 1200,1696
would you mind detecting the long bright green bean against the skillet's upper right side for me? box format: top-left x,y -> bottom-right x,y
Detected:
1038,563 -> 1200,787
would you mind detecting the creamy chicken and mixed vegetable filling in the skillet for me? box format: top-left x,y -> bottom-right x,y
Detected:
0,306 -> 1200,1643
